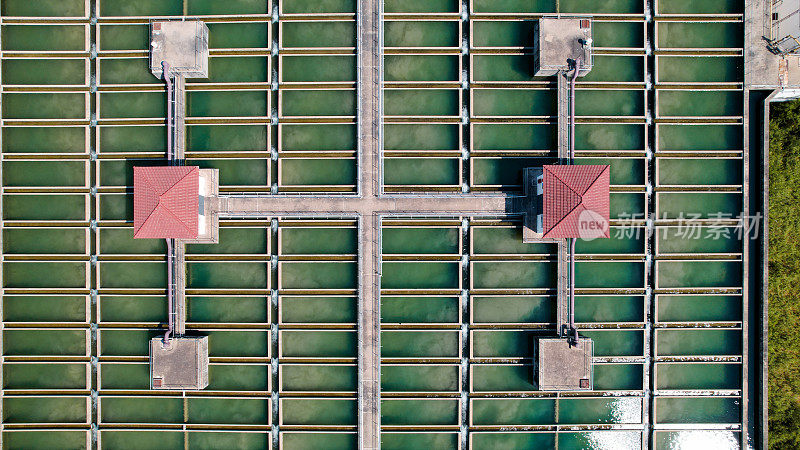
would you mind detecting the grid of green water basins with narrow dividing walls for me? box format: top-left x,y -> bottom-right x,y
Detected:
0,0 -> 754,444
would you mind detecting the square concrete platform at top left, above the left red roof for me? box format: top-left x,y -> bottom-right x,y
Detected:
150,20 -> 208,78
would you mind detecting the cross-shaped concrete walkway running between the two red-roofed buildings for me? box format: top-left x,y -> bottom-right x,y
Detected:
203,0 -> 522,449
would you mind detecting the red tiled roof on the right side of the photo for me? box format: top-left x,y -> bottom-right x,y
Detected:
542,165 -> 611,239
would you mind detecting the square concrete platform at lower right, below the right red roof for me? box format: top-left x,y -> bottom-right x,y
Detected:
535,338 -> 594,391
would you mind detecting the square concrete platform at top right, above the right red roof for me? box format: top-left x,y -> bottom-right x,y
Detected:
533,17 -> 592,77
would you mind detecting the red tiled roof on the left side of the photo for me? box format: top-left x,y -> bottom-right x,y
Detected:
133,166 -> 200,239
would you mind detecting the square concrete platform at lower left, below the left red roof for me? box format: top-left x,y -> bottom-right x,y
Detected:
150,336 -> 208,391
